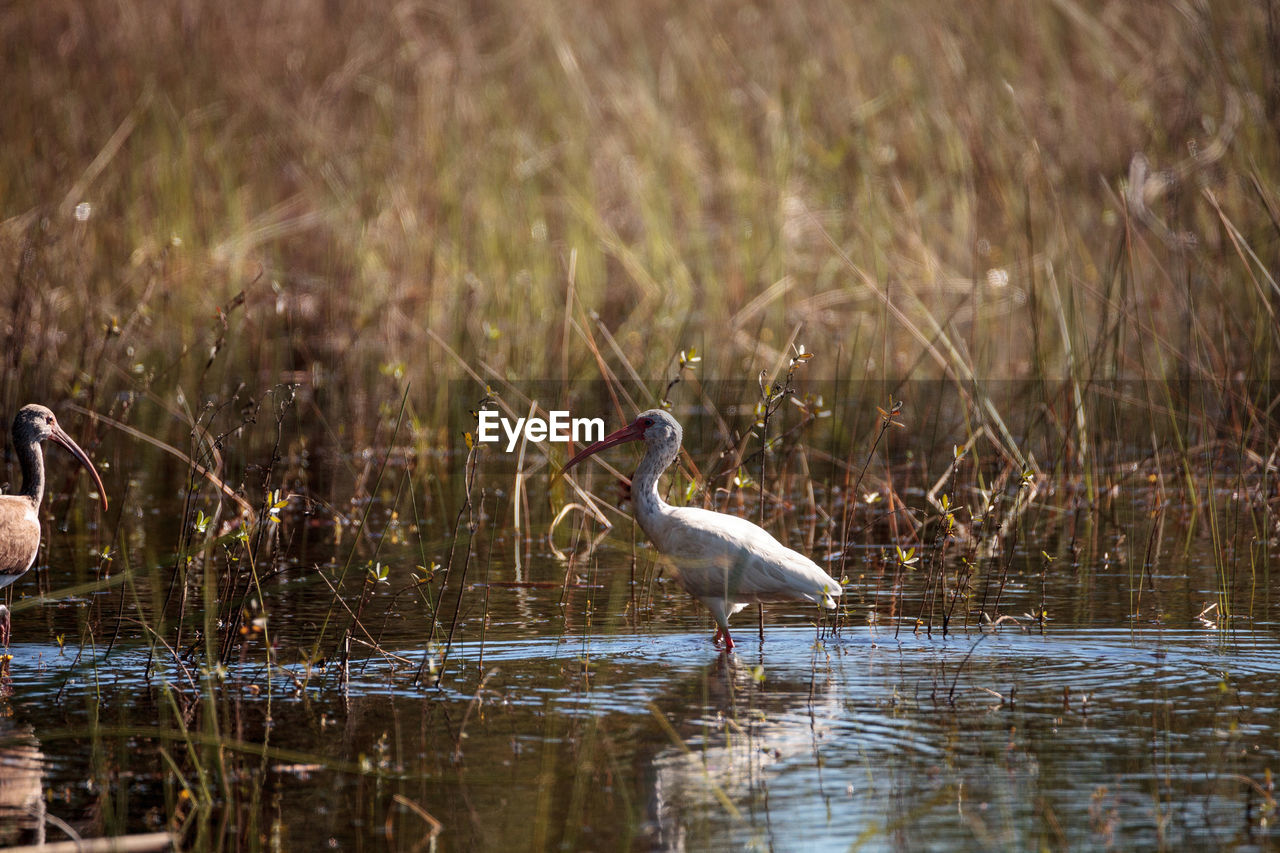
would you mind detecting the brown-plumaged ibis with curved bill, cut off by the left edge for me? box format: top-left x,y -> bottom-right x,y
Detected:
0,403 -> 106,646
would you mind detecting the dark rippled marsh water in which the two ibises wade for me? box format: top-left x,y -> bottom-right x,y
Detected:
0,399 -> 1280,850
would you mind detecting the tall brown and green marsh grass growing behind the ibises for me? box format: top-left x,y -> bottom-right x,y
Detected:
0,0 -> 1280,839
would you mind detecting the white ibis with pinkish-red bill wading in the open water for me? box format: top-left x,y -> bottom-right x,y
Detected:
562,409 -> 842,651
